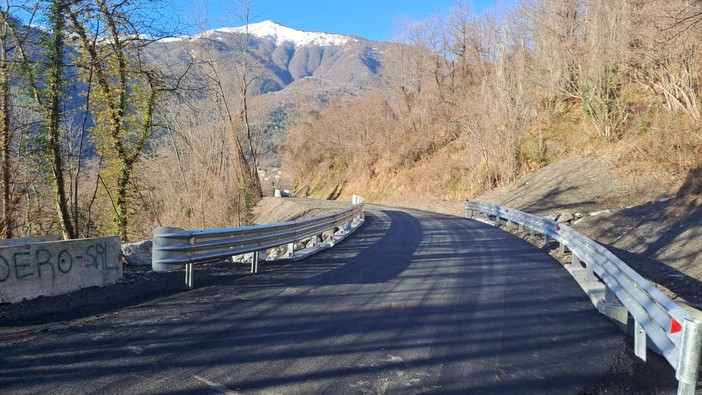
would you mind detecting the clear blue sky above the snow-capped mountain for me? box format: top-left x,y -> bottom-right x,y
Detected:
170,0 -> 504,41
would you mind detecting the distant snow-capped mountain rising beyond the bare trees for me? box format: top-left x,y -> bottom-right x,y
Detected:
159,21 -> 387,96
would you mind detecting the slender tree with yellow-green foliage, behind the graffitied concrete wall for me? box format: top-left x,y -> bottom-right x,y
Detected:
65,0 -> 164,241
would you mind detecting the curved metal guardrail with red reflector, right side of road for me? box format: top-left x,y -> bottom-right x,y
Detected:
466,202 -> 702,395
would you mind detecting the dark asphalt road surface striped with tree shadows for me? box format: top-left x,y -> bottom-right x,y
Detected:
0,206 -> 674,394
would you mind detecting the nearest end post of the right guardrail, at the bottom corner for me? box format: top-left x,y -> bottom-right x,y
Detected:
675,318 -> 702,395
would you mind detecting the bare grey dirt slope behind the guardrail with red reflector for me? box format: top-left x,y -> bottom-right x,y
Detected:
476,158 -> 702,308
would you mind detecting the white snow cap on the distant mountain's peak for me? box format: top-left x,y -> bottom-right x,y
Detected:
213,21 -> 355,47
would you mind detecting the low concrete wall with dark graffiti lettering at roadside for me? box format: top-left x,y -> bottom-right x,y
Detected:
0,237 -> 122,303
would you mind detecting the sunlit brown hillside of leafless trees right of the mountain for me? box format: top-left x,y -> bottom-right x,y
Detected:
282,0 -> 702,203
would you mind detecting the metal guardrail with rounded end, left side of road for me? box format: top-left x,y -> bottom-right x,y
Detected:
151,196 -> 364,288
